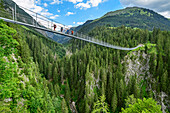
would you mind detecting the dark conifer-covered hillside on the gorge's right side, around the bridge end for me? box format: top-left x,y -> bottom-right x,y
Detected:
65,26 -> 170,112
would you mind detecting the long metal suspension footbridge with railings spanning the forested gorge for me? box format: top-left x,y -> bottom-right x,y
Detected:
0,2 -> 143,50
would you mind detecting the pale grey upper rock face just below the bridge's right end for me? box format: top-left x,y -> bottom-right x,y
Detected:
123,51 -> 151,84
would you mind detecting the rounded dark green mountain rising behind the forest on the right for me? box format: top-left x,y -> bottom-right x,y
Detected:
76,7 -> 170,33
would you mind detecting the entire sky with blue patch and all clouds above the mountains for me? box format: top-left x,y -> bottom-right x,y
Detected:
13,0 -> 170,26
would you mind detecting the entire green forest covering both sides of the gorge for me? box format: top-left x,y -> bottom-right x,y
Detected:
0,14 -> 170,113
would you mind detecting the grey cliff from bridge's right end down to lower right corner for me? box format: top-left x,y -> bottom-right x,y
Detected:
122,51 -> 169,113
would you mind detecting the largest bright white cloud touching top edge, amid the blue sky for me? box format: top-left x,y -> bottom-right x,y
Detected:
75,0 -> 106,9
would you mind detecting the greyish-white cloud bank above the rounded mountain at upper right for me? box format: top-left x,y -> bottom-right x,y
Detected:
120,0 -> 170,18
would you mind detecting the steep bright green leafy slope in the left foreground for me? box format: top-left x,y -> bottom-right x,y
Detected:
0,20 -> 66,113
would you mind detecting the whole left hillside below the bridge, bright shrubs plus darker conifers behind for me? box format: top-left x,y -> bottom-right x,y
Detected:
0,20 -> 65,113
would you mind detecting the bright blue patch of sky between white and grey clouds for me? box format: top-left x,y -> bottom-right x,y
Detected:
43,0 -> 123,26
